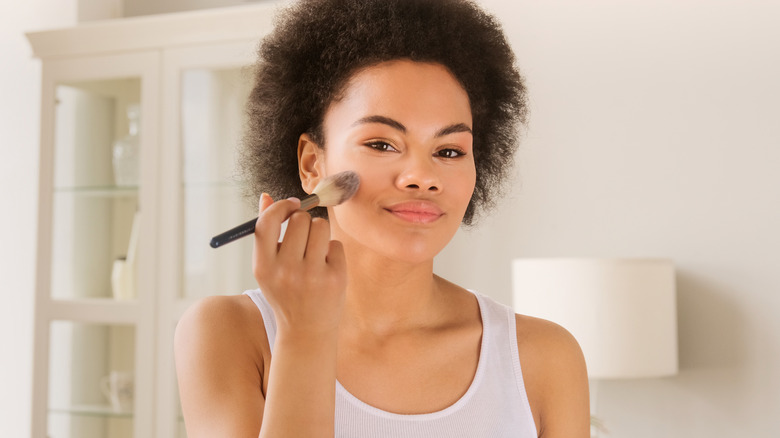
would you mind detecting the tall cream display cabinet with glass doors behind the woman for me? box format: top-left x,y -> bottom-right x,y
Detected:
28,3 -> 276,438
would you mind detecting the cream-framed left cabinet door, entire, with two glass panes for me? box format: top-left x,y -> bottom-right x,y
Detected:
33,53 -> 159,438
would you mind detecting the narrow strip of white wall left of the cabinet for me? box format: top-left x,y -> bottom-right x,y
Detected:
0,0 -> 76,438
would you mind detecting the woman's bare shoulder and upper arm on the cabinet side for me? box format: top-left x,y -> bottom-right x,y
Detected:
174,295 -> 270,437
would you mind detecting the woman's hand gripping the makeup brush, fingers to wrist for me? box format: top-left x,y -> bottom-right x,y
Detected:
252,193 -> 347,334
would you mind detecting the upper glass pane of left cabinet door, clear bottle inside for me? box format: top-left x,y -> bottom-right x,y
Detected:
50,78 -> 143,300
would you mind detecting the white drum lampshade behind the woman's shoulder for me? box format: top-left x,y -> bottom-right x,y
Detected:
512,259 -> 678,379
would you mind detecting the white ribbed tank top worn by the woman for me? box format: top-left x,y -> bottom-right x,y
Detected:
244,290 -> 537,438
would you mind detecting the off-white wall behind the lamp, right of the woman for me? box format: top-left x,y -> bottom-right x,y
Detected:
437,0 -> 780,438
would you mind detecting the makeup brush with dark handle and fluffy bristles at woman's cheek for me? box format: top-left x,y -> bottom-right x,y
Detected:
210,170 -> 360,248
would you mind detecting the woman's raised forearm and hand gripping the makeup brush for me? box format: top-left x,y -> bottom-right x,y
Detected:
253,195 -> 347,437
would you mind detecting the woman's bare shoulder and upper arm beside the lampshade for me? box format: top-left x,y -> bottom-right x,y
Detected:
515,315 -> 590,438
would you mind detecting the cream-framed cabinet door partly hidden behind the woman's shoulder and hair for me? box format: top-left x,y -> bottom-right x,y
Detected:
157,41 -> 257,437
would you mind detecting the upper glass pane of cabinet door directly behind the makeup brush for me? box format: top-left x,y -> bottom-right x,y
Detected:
180,67 -> 257,299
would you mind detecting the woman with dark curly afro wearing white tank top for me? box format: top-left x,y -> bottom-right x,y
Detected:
176,0 -> 589,438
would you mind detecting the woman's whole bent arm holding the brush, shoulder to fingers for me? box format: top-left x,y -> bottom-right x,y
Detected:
176,196 -> 346,438
